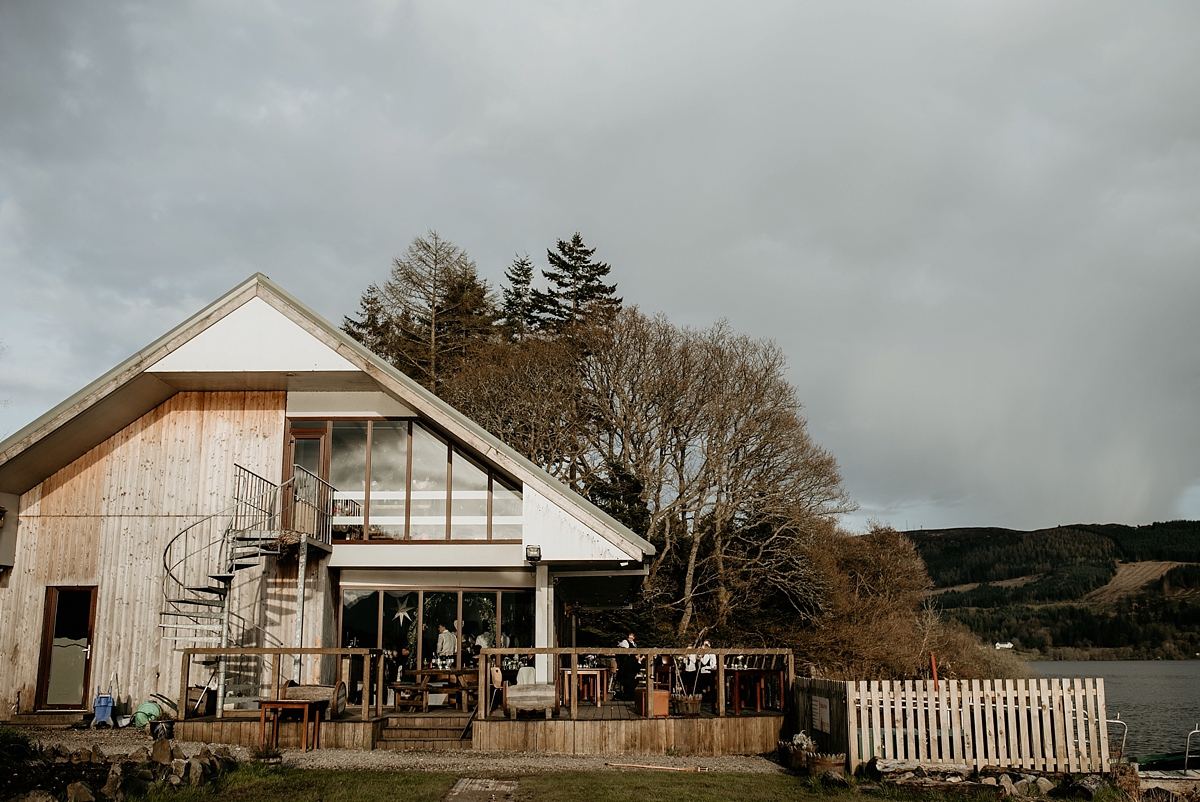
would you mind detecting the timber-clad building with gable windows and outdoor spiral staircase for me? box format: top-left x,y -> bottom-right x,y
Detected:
0,275 -> 654,719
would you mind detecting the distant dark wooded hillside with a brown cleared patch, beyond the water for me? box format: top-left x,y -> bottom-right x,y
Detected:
907,521 -> 1200,659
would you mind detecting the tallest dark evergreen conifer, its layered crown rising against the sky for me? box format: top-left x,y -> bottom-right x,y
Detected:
533,232 -> 622,330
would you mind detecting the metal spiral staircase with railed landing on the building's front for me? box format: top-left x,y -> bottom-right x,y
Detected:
158,465 -> 360,714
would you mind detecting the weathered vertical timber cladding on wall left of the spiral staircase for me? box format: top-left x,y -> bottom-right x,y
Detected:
0,393 -> 285,717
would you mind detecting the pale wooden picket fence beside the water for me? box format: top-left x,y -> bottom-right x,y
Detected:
846,678 -> 1109,773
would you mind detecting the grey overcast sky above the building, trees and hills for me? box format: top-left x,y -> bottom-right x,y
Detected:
0,0 -> 1200,528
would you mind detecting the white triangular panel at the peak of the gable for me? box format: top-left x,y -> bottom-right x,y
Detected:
149,297 -> 358,373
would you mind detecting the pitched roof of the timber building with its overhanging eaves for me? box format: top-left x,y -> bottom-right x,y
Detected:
0,274 -> 655,558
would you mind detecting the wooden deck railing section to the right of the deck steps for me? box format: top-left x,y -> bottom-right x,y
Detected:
479,647 -> 796,719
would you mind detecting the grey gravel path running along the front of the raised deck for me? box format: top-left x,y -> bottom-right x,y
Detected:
13,726 -> 784,777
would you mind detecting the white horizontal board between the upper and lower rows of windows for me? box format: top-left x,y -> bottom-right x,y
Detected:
329,541 -> 528,569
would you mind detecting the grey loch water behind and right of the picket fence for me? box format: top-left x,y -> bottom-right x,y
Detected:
1030,660 -> 1200,755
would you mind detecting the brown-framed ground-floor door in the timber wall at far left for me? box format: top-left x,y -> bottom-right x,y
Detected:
36,587 -> 96,710
